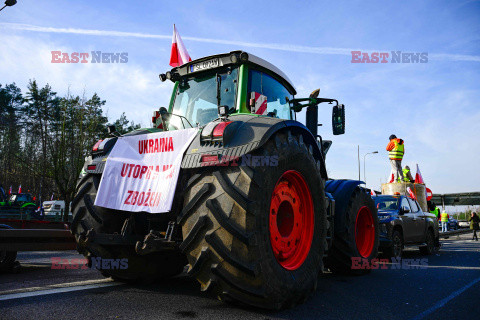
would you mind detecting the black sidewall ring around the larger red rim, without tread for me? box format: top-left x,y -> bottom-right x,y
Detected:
249,137 -> 326,295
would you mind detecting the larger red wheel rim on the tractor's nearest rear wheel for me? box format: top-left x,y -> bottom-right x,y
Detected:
269,170 -> 315,270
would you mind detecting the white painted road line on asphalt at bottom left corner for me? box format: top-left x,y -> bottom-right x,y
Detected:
0,279 -> 123,301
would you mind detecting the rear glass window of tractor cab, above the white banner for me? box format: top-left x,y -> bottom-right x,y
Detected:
170,68 -> 238,128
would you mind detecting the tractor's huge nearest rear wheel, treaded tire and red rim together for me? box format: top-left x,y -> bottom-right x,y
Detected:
177,131 -> 326,309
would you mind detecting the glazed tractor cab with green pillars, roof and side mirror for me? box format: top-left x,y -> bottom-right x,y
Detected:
156,51 -> 345,136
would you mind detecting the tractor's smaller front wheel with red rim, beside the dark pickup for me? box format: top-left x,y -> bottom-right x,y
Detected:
327,187 -> 379,275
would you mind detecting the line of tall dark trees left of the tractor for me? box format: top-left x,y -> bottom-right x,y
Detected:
0,80 -> 140,219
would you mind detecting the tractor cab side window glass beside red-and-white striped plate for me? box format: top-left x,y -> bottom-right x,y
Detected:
247,69 -> 293,119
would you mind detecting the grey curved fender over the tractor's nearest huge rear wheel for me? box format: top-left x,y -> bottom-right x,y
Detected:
182,114 -> 328,180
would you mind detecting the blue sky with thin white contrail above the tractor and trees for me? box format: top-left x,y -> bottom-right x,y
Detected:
0,0 -> 480,193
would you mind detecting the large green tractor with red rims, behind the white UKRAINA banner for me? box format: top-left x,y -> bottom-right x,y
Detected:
71,51 -> 379,309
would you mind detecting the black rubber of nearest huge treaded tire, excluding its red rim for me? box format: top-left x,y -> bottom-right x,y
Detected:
177,131 -> 326,309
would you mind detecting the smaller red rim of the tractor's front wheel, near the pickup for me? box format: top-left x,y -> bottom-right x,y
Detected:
355,206 -> 375,258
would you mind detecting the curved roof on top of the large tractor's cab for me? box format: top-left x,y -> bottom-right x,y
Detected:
171,50 -> 297,95
